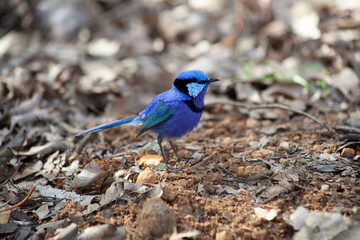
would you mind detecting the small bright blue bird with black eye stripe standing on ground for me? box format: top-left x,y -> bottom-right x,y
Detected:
76,70 -> 219,171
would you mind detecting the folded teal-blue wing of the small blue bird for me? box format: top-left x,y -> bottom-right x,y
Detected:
136,103 -> 175,137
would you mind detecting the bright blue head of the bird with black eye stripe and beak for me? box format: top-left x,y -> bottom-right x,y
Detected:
174,70 -> 218,98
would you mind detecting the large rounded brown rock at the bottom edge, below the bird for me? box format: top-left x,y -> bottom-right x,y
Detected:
137,198 -> 176,239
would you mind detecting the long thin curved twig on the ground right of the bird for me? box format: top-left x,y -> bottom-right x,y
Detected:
214,102 -> 337,135
